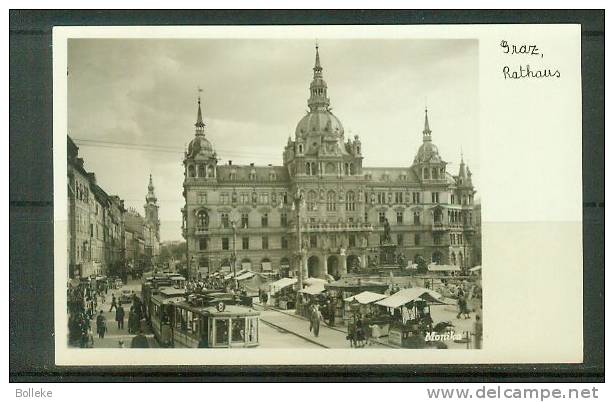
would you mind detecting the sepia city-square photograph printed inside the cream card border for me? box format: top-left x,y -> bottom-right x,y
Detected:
65,37 -> 488,349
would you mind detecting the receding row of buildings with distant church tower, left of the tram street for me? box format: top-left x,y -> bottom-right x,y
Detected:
67,136 -> 160,278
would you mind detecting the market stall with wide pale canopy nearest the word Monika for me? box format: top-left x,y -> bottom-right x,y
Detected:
375,287 -> 446,349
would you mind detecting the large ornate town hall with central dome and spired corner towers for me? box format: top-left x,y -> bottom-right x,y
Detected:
182,47 -> 475,277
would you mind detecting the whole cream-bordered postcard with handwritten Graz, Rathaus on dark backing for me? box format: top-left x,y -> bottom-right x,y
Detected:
53,25 -> 583,365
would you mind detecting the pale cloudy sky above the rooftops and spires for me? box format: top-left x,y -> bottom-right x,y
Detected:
68,38 -> 480,241
